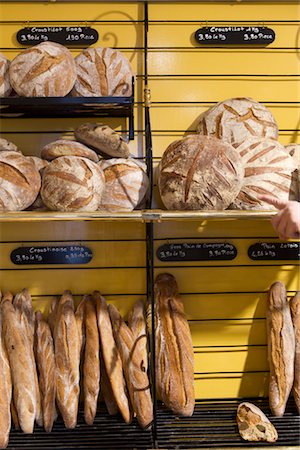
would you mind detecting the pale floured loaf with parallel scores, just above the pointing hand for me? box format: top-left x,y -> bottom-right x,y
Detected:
230,137 -> 296,209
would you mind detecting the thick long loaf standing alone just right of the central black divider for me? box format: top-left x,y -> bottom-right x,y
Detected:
154,273 -> 195,416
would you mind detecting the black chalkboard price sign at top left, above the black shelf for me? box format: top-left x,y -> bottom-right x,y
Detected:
17,26 -> 99,46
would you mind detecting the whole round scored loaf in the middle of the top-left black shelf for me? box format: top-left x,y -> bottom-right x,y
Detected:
9,41 -> 76,97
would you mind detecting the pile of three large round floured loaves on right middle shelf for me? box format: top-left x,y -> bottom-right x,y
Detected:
158,98 -> 299,210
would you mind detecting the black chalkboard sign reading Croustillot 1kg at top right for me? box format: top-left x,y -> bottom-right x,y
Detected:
195,27 -> 275,45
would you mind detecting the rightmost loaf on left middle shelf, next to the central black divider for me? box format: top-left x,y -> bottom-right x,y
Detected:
99,158 -> 149,212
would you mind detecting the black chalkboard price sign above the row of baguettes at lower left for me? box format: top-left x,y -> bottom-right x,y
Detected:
10,245 -> 93,265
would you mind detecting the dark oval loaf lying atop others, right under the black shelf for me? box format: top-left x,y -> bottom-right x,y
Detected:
74,123 -> 129,158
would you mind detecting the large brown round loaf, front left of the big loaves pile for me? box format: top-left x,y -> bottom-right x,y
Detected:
158,135 -> 244,210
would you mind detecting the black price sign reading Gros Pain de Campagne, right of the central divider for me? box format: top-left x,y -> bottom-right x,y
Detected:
156,242 -> 237,261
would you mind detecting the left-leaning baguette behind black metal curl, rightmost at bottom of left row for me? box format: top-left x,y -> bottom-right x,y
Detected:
108,305 -> 153,428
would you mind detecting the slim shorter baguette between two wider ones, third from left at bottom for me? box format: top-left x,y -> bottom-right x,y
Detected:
35,311 -> 56,433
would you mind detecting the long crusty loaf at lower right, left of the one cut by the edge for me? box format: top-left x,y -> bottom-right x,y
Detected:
266,281 -> 295,417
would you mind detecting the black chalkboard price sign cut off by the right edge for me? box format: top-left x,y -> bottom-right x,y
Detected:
248,242 -> 300,261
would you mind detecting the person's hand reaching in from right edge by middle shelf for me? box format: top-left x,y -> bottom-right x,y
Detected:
258,195 -> 300,240
